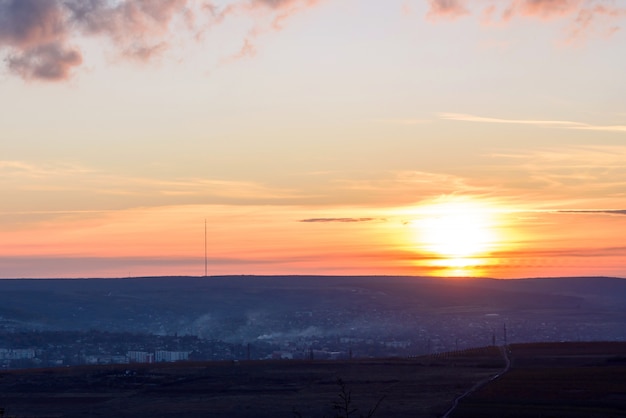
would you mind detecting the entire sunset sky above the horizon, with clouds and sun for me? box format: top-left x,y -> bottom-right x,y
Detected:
0,0 -> 626,278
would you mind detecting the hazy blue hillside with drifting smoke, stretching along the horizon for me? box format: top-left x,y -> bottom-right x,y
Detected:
0,276 -> 626,356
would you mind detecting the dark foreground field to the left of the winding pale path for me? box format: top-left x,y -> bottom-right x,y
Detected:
0,347 -> 504,418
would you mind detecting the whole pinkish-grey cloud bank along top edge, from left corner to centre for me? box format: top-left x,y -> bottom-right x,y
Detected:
0,0 -> 318,81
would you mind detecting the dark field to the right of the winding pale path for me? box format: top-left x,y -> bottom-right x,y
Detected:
450,343 -> 626,418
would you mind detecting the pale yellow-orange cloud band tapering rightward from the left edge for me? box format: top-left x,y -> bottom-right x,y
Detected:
0,160 -> 310,214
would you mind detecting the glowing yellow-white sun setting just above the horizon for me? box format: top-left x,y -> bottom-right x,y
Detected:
412,199 -> 499,275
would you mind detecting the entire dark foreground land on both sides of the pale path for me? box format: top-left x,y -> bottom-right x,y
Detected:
0,342 -> 626,418
